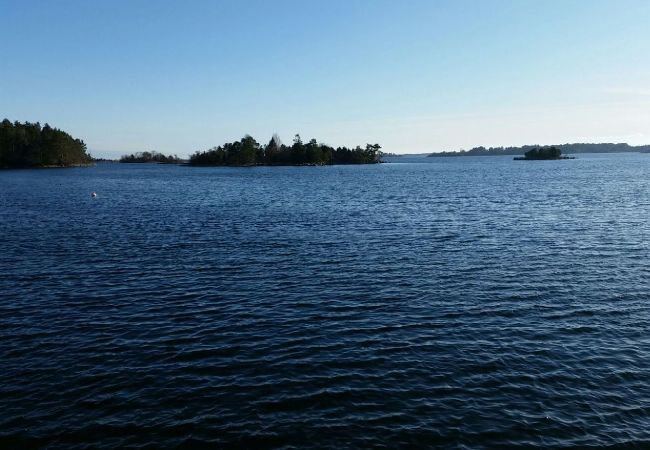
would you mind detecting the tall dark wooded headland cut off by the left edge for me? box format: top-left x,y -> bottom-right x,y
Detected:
0,119 -> 92,168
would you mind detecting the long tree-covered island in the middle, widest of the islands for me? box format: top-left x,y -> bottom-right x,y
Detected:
190,134 -> 381,166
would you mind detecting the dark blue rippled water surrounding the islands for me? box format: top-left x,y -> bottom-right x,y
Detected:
0,154 -> 650,449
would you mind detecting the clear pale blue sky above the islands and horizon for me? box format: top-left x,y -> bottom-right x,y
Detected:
0,0 -> 650,156
